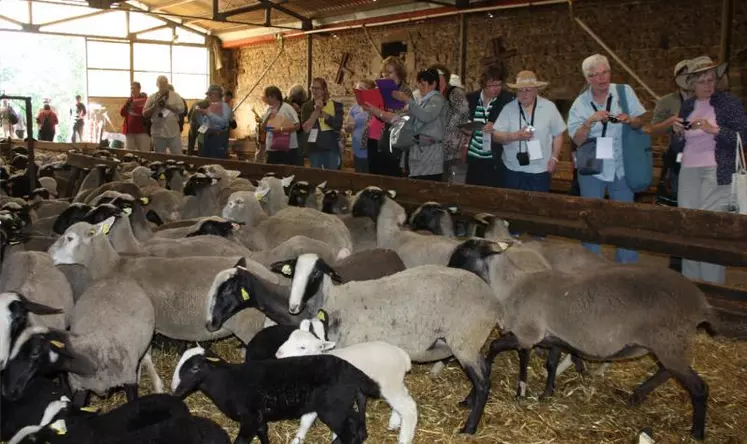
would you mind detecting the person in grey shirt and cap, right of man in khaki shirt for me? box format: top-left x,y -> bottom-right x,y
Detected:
195,85 -> 232,159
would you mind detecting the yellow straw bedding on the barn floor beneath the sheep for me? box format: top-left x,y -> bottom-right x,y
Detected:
70,243 -> 747,444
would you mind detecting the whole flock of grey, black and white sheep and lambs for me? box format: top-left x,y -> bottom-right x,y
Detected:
0,149 -> 747,444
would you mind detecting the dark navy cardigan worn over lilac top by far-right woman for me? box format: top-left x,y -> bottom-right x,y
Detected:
672,91 -> 747,185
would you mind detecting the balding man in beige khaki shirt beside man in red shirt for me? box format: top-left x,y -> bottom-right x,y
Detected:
143,76 -> 184,154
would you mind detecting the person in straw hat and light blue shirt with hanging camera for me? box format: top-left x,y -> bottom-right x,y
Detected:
493,71 -> 566,192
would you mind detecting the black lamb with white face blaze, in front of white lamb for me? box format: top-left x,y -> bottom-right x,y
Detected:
171,347 -> 381,444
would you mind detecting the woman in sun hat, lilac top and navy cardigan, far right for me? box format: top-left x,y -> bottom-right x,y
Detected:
674,56 -> 747,284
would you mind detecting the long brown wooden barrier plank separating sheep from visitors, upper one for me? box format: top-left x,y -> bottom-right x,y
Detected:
65,150 -> 747,266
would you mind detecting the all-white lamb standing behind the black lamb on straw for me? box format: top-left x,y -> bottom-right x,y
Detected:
275,329 -> 418,444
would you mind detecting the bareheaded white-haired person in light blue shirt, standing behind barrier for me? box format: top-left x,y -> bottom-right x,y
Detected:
568,54 -> 646,263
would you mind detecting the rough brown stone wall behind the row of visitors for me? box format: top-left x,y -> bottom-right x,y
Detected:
231,0 -> 747,141
